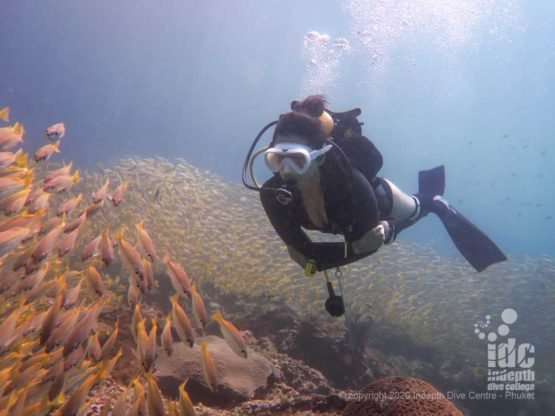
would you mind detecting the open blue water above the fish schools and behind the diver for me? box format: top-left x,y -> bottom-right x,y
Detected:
0,0 -> 555,255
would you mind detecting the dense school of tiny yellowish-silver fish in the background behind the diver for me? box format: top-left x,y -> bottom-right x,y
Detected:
82,157 -> 555,392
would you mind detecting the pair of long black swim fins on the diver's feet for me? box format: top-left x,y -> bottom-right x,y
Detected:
418,166 -> 507,272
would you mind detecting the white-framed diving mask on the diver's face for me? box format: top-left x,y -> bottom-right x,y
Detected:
264,142 -> 332,175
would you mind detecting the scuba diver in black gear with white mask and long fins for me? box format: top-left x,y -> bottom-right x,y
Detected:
243,95 -> 506,315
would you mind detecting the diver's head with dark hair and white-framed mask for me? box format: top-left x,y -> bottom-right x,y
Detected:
265,96 -> 333,181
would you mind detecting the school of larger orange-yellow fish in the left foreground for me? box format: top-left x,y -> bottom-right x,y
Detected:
0,107 -> 247,416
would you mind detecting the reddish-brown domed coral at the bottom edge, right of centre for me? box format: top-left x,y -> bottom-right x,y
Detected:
343,377 -> 462,416
